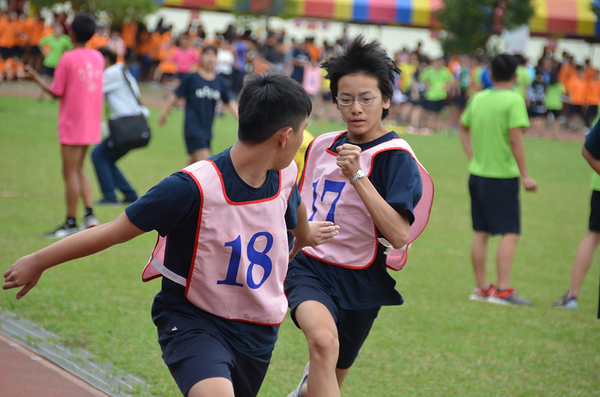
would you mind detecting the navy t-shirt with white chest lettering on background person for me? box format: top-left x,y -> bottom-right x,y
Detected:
175,73 -> 229,140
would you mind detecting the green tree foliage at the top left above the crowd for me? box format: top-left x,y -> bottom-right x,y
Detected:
29,0 -> 160,26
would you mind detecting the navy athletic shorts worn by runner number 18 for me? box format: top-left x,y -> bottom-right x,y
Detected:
155,313 -> 273,397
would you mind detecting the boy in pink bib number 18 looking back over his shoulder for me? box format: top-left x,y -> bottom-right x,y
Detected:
2,73 -> 338,397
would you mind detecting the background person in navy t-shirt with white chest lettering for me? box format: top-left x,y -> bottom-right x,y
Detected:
158,46 -> 238,165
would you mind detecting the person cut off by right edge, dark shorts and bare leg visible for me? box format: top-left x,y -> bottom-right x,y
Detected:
554,116 -> 600,319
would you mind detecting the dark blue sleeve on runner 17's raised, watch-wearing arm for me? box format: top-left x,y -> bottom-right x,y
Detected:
369,150 -> 423,224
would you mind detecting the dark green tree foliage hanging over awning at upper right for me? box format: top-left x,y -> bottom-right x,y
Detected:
436,0 -> 533,54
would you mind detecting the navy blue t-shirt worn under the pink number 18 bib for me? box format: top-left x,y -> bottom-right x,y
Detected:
125,149 -> 301,352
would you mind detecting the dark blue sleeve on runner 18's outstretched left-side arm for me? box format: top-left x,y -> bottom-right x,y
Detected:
125,172 -> 200,236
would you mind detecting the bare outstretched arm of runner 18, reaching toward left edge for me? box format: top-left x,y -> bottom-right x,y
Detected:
2,214 -> 144,299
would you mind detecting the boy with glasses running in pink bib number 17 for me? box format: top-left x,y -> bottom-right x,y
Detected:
285,37 -> 433,397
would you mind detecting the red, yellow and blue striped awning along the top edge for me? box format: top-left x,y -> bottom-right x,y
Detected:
157,0 -> 600,37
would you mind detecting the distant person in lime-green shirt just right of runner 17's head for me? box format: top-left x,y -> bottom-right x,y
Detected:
421,58 -> 454,130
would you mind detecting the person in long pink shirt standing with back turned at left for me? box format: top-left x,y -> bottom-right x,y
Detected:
23,14 -> 104,238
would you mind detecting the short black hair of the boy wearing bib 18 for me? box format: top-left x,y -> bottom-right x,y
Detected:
238,72 -> 312,144
